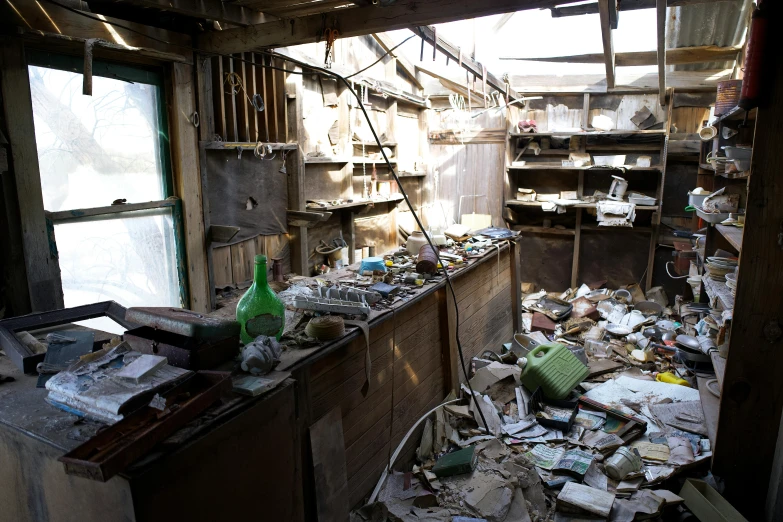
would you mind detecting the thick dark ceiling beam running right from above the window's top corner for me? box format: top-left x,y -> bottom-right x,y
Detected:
199,0 -> 568,54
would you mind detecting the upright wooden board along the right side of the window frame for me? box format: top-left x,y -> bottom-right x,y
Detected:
169,63 -> 212,312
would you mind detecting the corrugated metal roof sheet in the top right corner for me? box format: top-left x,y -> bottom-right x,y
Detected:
666,0 -> 753,71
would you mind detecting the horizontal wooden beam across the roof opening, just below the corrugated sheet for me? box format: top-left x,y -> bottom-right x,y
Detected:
500,45 -> 742,67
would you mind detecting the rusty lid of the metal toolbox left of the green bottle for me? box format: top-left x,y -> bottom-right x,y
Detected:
125,306 -> 239,339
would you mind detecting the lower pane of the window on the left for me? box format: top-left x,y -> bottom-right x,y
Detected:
54,208 -> 181,308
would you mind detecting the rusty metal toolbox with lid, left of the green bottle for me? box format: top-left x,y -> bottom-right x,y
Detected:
123,307 -> 239,370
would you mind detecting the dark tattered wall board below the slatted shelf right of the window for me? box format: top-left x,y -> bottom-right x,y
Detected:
206,150 -> 288,241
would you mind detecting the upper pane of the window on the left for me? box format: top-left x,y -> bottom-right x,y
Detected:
28,66 -> 166,212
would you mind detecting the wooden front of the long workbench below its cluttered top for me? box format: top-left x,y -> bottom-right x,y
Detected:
0,241 -> 520,521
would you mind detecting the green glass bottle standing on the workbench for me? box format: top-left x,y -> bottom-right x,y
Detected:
237,256 -> 285,344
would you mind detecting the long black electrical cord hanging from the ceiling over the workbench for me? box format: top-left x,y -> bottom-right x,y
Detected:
36,0 -> 490,434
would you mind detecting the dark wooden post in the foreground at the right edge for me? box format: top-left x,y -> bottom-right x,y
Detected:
713,34 -> 783,520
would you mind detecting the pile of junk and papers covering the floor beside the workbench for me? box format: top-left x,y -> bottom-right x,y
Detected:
351,283 -> 744,522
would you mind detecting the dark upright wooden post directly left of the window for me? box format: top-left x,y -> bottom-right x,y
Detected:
0,38 -> 64,312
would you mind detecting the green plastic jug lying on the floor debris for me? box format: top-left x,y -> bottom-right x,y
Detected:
519,343 -> 590,399
